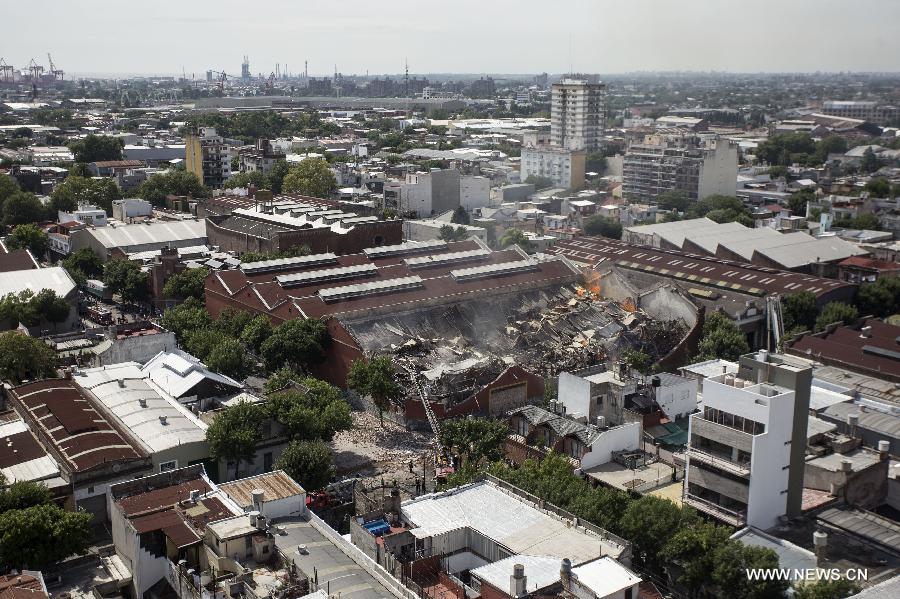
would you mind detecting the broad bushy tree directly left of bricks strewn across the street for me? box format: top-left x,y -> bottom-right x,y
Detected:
269,377 -> 352,441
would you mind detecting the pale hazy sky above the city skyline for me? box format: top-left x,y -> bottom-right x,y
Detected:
7,0 -> 900,77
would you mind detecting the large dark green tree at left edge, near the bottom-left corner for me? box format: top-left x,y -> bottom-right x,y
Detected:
0,503 -> 92,569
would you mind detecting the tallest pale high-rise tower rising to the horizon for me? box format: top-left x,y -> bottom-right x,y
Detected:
550,78 -> 606,152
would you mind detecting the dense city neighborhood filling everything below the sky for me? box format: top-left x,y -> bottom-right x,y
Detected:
0,5 -> 900,599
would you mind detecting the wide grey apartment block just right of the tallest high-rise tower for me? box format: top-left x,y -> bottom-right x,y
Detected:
622,135 -> 738,202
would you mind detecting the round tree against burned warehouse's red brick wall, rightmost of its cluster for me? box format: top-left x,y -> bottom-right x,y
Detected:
260,318 -> 331,372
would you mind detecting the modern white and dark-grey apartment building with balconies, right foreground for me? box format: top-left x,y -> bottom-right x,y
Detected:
683,350 -> 812,530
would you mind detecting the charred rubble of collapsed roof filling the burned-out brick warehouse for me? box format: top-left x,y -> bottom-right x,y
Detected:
344,286 -> 687,407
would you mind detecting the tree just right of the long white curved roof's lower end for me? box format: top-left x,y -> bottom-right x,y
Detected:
206,401 -> 266,478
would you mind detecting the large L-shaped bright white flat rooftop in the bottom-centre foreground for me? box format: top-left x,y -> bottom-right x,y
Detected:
401,482 -> 625,564
